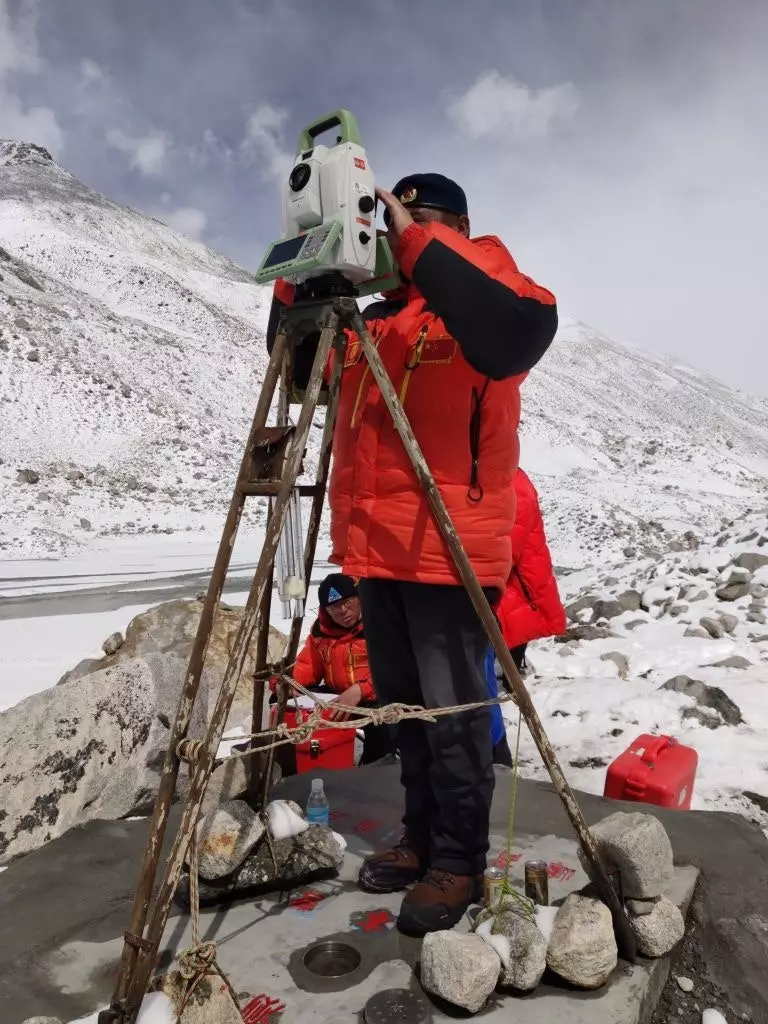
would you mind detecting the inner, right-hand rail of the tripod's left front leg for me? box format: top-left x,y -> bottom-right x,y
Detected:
127,312 -> 338,1024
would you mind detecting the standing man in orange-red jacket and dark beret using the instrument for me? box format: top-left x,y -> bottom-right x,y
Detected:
268,174 -> 557,935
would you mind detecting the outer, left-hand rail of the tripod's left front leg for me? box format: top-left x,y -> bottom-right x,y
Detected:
99,332 -> 287,1024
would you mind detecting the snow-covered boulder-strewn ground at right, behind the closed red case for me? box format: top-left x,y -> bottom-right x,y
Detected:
512,509 -> 768,835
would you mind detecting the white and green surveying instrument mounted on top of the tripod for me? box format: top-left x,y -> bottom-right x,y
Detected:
255,110 -> 394,295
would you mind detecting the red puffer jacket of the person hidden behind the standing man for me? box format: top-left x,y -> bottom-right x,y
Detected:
496,469 -> 565,647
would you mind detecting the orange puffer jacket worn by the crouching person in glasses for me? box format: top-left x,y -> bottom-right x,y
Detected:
291,608 -> 376,701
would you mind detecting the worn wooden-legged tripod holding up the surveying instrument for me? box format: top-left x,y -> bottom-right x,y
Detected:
99,296 -> 636,1024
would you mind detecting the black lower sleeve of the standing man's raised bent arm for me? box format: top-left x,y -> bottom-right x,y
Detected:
413,239 -> 557,381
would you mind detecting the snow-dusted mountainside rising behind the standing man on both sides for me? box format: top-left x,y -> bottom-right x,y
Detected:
0,142 -> 768,568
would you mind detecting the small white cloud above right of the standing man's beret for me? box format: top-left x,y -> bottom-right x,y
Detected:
449,71 -> 579,138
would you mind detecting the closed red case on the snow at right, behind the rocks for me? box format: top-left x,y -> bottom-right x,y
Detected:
603,733 -> 698,811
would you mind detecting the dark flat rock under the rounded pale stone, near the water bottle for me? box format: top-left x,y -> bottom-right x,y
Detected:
179,825 -> 344,906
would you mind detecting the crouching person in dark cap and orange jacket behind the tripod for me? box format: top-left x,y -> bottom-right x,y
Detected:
270,572 -> 396,774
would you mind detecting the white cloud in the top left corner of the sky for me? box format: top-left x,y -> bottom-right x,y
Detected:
0,0 -> 63,153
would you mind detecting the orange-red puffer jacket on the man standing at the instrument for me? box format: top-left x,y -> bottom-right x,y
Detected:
268,222 -> 557,591
